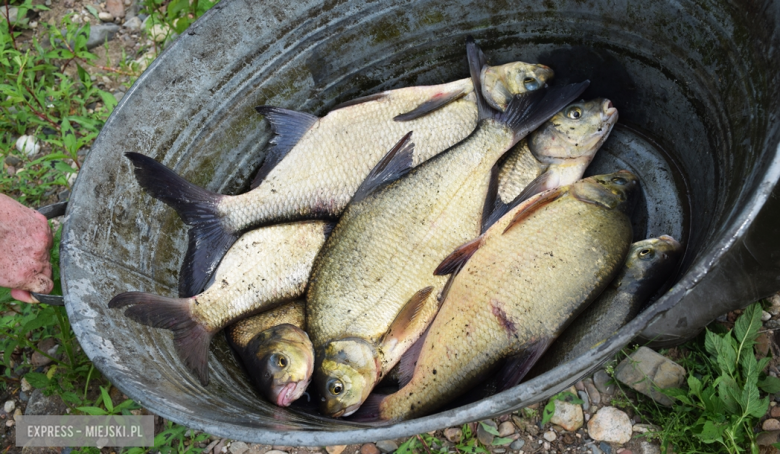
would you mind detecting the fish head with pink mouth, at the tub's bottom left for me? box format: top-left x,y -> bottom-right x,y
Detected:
243,324 -> 314,407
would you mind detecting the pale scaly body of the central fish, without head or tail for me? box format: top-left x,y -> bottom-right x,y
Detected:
307,120 -> 512,348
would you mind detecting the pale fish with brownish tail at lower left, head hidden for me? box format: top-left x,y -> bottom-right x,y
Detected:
109,221 -> 332,385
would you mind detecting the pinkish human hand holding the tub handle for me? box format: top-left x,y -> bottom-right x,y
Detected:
0,194 -> 54,303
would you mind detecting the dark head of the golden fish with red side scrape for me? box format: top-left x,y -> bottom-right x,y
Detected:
571,170 -> 640,215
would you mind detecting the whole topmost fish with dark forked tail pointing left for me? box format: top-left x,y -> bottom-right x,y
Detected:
126,58 -> 552,296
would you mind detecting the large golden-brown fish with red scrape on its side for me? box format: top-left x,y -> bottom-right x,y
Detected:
376,171 -> 639,421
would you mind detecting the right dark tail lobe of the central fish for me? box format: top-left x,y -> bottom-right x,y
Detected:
495,80 -> 590,141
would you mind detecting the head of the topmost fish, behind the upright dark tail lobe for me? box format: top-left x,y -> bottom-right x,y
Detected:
479,61 -> 553,112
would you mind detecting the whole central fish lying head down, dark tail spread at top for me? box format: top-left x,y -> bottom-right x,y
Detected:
307,39 -> 588,417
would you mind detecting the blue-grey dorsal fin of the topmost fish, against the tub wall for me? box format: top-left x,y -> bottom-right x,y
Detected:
251,106 -> 319,189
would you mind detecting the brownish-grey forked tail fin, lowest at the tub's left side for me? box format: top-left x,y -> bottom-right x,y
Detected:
108,292 -> 213,386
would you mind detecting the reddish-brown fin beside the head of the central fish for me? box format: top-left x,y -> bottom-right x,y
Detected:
379,286 -> 439,374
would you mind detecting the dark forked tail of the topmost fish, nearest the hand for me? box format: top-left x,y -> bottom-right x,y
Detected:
125,152 -> 239,297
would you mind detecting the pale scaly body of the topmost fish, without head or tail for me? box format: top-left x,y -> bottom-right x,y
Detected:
219,79 -> 477,231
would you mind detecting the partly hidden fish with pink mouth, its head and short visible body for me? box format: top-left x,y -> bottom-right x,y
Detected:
225,300 -> 314,407
